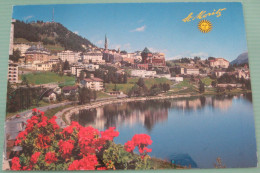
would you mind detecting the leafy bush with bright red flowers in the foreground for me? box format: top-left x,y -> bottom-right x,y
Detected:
11,109 -> 152,170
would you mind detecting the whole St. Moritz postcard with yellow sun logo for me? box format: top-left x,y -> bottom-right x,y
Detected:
3,2 -> 257,171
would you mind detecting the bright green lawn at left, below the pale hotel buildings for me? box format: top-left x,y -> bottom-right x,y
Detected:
22,72 -> 75,85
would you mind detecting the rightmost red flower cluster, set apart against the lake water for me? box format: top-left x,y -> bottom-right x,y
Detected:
125,134 -> 153,154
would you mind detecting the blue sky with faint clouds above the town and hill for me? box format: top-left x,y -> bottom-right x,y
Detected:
13,2 -> 247,61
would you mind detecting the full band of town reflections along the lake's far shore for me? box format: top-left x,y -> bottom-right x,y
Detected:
71,94 -> 252,131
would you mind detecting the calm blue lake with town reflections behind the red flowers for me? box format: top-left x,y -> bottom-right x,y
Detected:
71,95 -> 257,168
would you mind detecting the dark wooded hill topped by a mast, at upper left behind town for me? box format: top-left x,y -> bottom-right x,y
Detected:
14,20 -> 96,52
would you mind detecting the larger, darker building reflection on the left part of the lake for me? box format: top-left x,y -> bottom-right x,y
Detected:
71,101 -> 170,130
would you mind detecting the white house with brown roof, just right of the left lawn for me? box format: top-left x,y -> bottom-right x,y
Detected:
80,77 -> 104,91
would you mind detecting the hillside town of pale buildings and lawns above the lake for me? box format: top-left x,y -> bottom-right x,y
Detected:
7,21 -> 251,115
